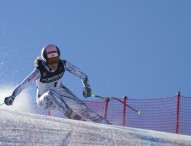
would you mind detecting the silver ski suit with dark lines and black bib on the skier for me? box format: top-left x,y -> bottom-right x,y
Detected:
12,59 -> 109,124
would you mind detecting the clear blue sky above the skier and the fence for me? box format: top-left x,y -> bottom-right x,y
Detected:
0,0 -> 191,98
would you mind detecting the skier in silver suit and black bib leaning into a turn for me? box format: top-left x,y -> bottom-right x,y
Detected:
4,44 -> 110,124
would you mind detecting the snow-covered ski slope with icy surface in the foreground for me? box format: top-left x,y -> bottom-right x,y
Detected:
0,107 -> 191,146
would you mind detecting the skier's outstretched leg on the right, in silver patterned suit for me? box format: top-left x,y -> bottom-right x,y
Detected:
58,85 -> 110,124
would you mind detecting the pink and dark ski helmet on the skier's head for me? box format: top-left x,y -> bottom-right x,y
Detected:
41,44 -> 60,62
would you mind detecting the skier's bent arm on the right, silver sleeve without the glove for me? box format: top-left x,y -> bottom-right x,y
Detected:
63,60 -> 90,88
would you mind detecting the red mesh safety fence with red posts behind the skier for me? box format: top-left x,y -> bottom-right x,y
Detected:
30,92 -> 191,135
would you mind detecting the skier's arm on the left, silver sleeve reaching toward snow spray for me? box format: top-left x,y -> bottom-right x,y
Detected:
11,69 -> 40,98
